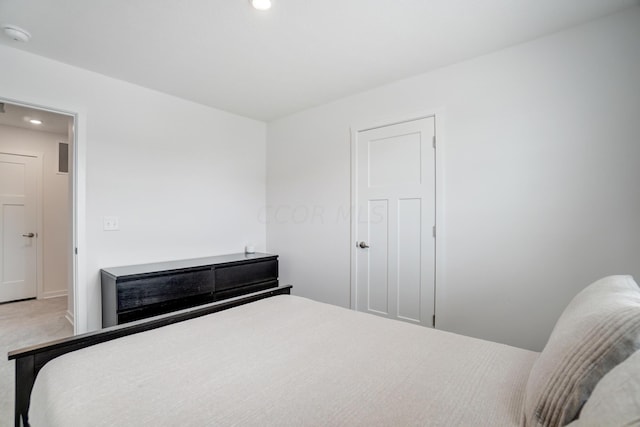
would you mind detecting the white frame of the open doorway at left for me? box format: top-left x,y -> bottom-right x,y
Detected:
0,96 -> 89,335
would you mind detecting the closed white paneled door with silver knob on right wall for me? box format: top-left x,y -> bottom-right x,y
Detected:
354,117 -> 435,326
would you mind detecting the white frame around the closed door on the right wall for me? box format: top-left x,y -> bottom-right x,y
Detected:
349,108 -> 446,327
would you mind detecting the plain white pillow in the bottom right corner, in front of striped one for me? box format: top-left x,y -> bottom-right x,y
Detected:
570,351 -> 640,427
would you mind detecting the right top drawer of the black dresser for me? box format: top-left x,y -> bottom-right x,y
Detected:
213,259 -> 278,292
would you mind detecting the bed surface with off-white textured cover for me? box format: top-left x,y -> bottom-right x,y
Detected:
29,295 -> 538,427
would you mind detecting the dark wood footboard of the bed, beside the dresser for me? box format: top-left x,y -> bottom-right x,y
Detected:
9,285 -> 291,427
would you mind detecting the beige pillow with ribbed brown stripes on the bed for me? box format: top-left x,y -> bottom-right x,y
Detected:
524,276 -> 640,426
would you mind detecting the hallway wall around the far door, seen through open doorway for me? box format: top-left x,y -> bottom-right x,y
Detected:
0,125 -> 70,298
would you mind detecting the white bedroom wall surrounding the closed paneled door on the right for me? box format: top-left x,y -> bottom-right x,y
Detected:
266,8 -> 640,350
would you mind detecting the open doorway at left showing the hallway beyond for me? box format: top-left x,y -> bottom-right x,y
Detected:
0,99 -> 75,330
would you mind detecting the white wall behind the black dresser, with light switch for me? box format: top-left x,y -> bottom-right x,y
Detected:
0,47 -> 265,331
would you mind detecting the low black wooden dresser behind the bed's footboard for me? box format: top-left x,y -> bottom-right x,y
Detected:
100,253 -> 278,328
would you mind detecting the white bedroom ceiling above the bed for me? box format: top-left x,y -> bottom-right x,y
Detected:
0,0 -> 639,121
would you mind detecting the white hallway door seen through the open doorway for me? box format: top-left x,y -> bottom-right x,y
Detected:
0,153 -> 40,302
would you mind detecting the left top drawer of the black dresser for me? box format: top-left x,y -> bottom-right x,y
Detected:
117,267 -> 213,311
